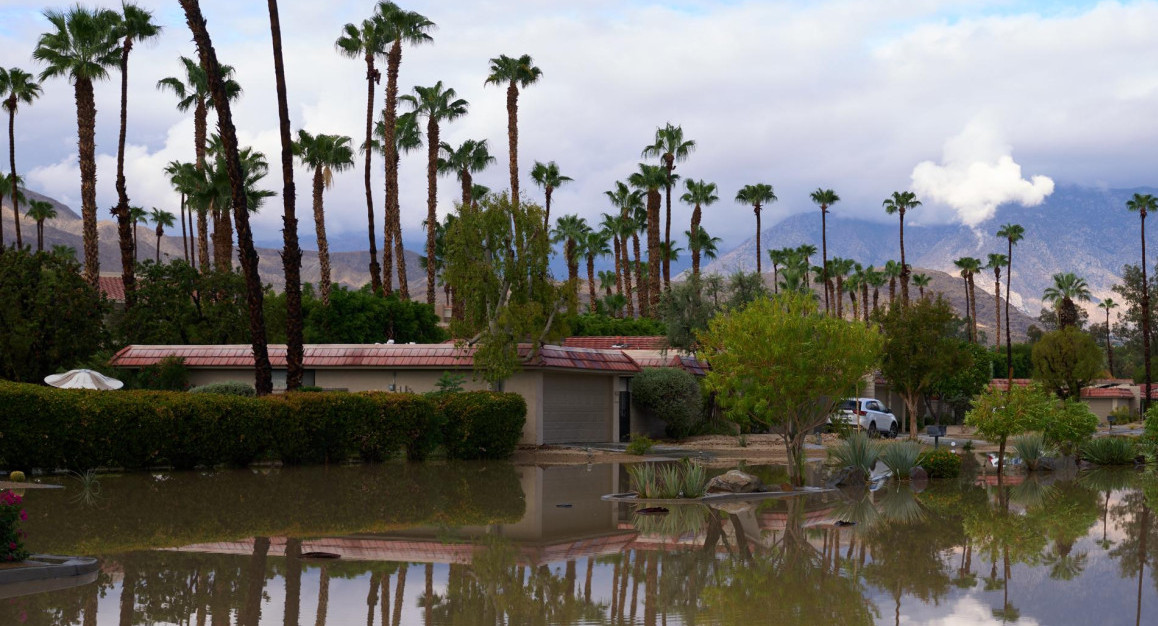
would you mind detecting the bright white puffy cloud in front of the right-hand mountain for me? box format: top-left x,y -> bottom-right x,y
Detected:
913,120 -> 1054,227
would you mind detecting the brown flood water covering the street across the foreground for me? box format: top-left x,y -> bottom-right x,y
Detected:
0,455 -> 1158,626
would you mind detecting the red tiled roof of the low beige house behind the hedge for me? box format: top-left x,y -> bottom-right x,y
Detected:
111,344 -> 639,373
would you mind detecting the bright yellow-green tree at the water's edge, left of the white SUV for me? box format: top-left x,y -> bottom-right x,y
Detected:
698,293 -> 884,485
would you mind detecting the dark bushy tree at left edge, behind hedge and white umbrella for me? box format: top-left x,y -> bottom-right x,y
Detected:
0,249 -> 109,383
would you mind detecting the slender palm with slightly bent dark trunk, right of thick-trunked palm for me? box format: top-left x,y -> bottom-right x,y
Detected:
112,2 -> 161,308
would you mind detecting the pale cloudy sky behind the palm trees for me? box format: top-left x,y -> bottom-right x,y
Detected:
0,0 -> 1158,258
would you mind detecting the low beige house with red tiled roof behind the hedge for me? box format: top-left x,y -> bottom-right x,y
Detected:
111,344 -> 639,444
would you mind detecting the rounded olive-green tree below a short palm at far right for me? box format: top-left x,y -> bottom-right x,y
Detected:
1032,326 -> 1102,400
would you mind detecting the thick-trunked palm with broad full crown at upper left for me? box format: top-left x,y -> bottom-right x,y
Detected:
32,6 -> 120,287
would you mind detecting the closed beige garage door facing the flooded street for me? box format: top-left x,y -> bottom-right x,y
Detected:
543,374 -> 611,443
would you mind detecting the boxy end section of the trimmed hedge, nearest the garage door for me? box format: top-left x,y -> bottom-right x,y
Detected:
439,391 -> 527,459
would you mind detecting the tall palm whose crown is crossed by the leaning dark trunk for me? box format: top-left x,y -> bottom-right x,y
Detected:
156,57 -> 241,272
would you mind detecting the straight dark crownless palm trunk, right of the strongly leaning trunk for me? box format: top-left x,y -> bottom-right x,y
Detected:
269,0 -> 305,391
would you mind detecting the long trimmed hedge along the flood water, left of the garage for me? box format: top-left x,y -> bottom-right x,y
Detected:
0,382 -> 527,470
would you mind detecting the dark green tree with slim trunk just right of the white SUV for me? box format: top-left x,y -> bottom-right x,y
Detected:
879,295 -> 973,439
